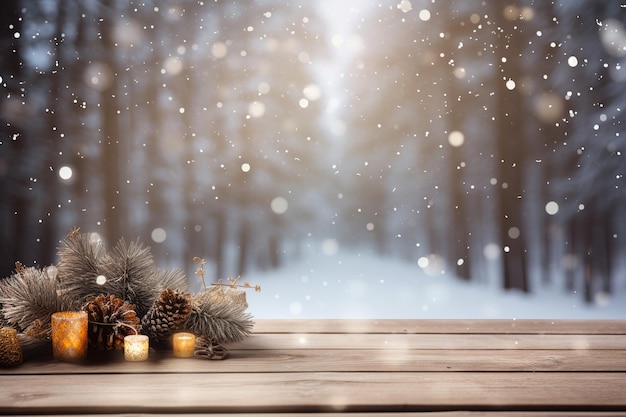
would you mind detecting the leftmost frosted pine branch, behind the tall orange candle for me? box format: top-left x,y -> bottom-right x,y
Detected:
0,267 -> 76,339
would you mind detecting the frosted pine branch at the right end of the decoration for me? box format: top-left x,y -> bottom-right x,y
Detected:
187,287 -> 254,343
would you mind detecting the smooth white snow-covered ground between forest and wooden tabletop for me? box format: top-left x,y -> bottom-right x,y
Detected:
242,245 -> 626,319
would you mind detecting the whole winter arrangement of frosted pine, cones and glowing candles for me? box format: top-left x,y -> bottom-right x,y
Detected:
0,228 -> 261,361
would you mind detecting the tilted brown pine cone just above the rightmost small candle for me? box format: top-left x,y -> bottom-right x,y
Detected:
141,288 -> 191,344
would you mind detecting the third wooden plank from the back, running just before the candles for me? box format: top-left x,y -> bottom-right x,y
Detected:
0,349 -> 626,377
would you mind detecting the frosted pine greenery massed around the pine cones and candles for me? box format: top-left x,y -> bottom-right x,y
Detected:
0,228 -> 261,360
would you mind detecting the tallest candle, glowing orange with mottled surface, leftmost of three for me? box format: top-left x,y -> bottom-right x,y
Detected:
52,311 -> 87,362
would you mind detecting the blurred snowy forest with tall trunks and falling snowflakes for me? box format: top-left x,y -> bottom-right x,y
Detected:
0,0 -> 626,318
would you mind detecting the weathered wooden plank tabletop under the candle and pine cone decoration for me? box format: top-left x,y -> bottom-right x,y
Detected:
0,320 -> 626,416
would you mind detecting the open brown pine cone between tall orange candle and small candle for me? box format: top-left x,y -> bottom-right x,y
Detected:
83,294 -> 140,350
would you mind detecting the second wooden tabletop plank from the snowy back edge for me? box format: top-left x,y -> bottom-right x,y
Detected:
231,333 -> 626,350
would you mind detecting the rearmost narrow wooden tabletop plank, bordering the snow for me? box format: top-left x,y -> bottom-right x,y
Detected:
254,319 -> 626,334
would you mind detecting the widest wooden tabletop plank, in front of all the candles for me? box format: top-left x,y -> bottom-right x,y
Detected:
0,372 -> 626,414
